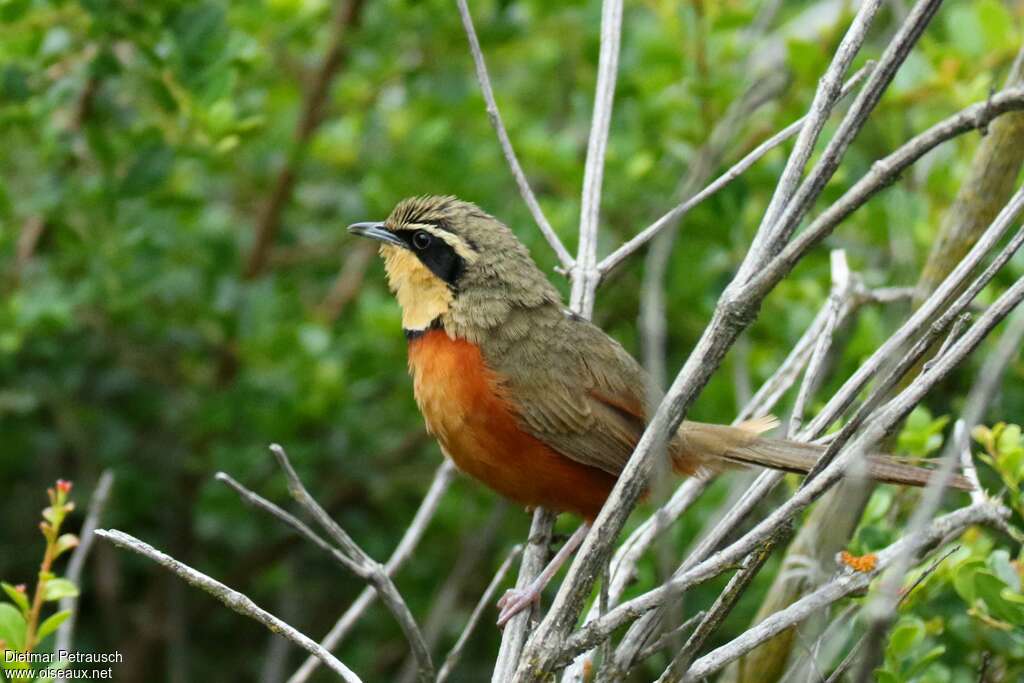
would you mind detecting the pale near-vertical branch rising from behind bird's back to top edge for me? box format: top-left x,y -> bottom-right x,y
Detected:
569,0 -> 623,319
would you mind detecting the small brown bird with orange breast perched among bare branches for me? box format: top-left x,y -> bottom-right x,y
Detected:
348,196 -> 971,626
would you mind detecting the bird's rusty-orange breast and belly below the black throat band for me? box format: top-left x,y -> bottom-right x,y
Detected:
409,330 -> 615,519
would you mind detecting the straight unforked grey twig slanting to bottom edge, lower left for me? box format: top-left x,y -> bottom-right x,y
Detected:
95,528 -> 360,683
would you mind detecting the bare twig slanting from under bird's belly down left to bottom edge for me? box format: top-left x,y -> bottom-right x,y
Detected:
288,458 -> 455,683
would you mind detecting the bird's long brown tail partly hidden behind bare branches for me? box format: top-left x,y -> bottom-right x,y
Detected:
673,418 -> 974,490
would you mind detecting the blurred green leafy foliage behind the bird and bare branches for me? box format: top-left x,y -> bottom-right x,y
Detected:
0,0 -> 1024,682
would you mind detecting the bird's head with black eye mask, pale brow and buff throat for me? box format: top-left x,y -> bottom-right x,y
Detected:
348,197 -> 559,336
